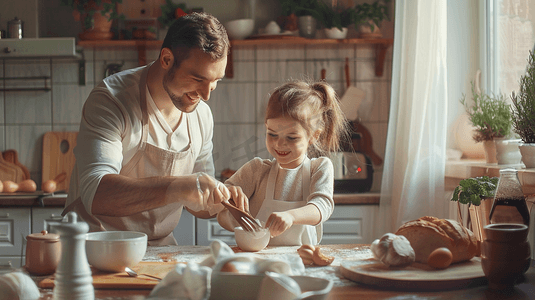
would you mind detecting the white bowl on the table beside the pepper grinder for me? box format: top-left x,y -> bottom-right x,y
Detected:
85,231 -> 147,272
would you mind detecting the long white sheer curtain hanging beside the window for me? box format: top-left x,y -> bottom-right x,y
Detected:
375,0 -> 449,236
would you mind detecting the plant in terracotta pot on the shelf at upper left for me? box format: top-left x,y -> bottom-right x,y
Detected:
60,0 -> 124,40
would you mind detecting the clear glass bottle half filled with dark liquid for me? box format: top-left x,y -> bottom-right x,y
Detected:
489,169 -> 529,226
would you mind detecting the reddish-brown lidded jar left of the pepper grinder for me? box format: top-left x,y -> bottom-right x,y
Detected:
25,230 -> 61,275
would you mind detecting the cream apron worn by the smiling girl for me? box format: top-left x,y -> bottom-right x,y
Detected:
256,157 -> 321,246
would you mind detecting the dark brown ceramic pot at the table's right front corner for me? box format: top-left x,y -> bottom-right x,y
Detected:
481,223 -> 531,290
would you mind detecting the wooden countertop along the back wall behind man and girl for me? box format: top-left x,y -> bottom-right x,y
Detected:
0,193 -> 381,207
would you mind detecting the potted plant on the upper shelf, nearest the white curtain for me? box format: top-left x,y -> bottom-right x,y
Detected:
355,0 -> 390,38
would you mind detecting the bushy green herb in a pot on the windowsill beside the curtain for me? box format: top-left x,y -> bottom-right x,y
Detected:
460,82 -> 512,163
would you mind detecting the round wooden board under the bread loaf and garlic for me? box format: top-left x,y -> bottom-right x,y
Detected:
340,257 -> 487,291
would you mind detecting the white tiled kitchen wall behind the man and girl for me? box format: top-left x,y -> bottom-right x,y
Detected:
0,44 -> 392,191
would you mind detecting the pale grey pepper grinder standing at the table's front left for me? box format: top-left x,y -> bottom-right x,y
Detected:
53,212 -> 95,300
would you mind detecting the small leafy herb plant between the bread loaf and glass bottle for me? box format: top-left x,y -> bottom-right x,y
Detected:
451,176 -> 499,241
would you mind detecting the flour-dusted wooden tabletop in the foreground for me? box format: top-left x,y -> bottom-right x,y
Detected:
32,244 -> 535,300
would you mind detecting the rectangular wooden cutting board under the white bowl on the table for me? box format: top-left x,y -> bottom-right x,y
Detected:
39,261 -> 180,290
